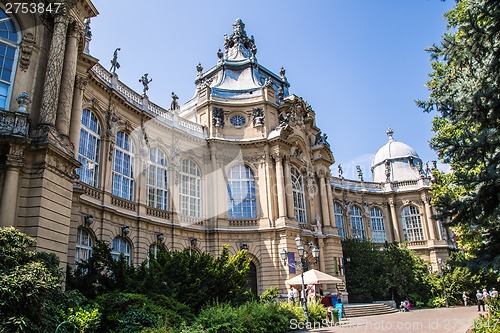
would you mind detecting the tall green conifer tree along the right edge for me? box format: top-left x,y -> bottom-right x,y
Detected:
417,0 -> 500,270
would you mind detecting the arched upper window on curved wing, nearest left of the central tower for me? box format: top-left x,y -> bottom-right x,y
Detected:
179,160 -> 201,217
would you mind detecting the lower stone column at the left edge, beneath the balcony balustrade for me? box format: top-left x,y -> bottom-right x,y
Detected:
0,145 -> 23,227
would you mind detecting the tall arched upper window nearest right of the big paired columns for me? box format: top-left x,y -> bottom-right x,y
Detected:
76,109 -> 101,187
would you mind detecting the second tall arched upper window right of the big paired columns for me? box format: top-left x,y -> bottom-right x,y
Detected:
113,132 -> 134,200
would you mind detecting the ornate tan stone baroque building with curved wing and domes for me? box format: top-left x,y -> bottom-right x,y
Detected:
0,0 -> 454,293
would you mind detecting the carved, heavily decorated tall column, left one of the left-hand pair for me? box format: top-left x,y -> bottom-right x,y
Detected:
40,15 -> 68,126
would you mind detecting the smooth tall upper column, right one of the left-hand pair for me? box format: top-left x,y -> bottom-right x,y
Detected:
56,23 -> 80,136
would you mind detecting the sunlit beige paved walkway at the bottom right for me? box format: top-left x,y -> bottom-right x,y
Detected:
298,306 -> 485,333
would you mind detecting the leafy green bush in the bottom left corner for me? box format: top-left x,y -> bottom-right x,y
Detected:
0,227 -> 62,332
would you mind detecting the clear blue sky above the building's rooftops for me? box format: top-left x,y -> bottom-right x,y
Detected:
90,0 -> 455,180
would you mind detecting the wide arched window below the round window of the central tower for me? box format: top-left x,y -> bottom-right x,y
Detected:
227,165 -> 257,219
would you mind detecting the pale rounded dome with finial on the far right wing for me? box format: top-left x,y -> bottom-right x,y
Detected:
371,127 -> 422,183
